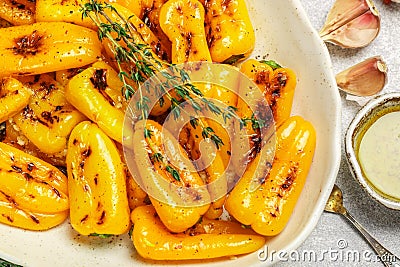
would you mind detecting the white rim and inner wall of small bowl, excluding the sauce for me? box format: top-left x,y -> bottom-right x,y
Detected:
345,92 -> 400,210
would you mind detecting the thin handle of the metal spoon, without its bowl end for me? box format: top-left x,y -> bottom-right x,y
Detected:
343,211 -> 400,267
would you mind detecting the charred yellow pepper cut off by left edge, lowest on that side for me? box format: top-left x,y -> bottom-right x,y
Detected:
0,142 -> 69,230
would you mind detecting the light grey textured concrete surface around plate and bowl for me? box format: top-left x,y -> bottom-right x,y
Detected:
276,0 -> 400,267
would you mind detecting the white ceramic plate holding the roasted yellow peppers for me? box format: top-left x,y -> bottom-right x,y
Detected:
0,0 -> 341,267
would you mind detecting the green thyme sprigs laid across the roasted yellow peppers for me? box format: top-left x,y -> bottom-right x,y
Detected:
81,0 -> 228,148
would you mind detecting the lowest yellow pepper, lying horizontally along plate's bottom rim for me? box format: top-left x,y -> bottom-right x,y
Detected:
131,206 -> 265,260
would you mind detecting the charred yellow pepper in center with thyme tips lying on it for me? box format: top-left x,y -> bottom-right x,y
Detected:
132,120 -> 210,233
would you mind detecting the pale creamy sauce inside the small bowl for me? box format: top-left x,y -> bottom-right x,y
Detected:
357,111 -> 400,200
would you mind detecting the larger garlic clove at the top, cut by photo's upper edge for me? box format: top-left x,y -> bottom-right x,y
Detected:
320,0 -> 380,48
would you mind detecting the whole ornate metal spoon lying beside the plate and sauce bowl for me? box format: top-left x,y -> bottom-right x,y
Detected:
325,185 -> 400,267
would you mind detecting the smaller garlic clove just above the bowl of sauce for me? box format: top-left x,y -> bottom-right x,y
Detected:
336,56 -> 387,96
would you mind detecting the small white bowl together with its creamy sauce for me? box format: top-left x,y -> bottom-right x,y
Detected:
344,92 -> 400,211
